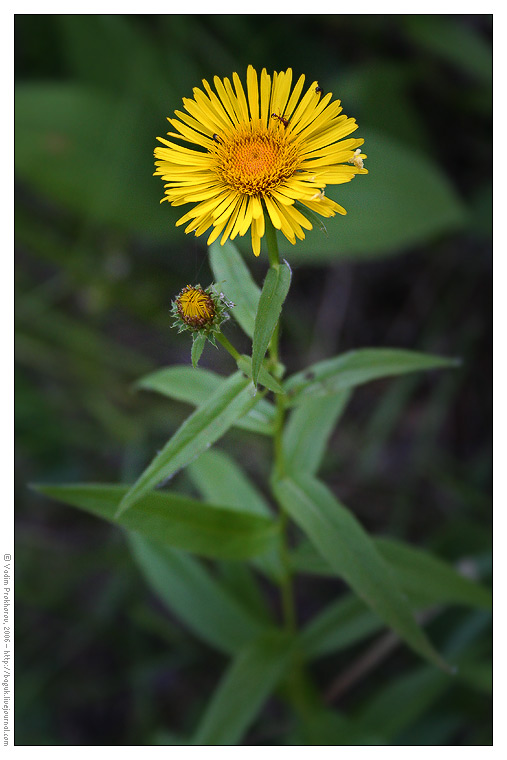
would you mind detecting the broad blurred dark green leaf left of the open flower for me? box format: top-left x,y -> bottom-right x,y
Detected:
15,82 -> 177,241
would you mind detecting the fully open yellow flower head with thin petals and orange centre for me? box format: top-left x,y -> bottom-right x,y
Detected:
155,66 -> 367,256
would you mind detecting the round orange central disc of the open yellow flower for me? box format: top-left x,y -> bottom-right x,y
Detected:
216,127 -> 298,195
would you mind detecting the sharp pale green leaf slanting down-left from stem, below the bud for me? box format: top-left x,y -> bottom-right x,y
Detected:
118,371 -> 257,515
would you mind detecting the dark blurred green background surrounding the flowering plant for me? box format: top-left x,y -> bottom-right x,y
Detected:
15,15 -> 492,745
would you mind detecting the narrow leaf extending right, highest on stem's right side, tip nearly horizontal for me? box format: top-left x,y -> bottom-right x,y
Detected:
284,348 -> 459,404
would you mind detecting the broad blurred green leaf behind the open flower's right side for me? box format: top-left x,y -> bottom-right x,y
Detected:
274,129 -> 467,265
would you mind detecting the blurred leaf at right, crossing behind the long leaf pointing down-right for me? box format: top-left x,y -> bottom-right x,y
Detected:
291,538 -> 491,609
